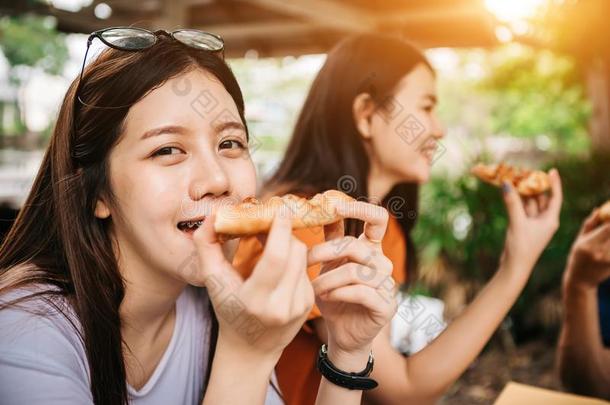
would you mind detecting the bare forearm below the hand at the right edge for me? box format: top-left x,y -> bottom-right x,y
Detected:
557,283 -> 610,398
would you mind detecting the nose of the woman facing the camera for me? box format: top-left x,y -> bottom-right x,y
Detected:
189,153 -> 230,201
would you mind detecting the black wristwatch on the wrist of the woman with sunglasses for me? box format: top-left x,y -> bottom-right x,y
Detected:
316,344 -> 378,391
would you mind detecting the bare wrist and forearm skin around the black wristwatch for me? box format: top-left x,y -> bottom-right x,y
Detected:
316,342 -> 369,405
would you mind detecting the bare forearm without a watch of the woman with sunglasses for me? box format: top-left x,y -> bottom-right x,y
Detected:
202,339 -> 275,405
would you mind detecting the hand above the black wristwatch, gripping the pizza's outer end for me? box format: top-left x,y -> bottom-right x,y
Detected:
308,202 -> 396,371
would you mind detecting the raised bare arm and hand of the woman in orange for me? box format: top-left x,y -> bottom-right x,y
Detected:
317,171 -> 562,404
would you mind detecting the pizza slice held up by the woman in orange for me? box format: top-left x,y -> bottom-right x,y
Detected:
471,163 -> 551,197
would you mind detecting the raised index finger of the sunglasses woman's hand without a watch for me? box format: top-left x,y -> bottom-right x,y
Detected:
248,215 -> 292,290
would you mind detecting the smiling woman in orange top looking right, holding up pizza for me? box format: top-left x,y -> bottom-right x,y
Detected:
235,34 -> 562,404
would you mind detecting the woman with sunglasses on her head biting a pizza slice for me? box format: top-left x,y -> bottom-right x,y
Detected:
0,28 -> 395,404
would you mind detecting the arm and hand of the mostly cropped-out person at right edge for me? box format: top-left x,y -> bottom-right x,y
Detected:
557,210 -> 610,399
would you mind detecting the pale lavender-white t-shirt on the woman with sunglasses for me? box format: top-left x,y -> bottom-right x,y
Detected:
0,287 -> 283,405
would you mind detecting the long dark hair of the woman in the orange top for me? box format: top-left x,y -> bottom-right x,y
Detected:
265,34 -> 433,280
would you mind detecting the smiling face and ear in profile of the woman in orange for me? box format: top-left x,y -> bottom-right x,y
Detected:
354,64 -> 444,184
